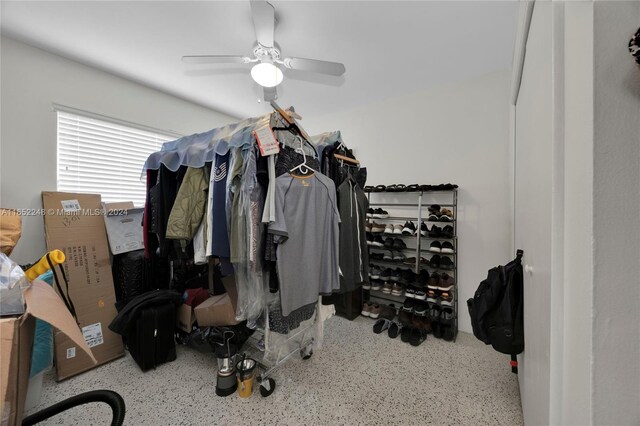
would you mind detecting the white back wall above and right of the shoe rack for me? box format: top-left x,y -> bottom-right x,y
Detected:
300,70 -> 514,332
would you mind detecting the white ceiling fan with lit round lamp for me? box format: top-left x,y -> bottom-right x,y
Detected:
182,0 -> 345,102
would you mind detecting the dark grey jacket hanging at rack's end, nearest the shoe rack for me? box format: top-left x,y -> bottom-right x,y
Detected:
338,177 -> 369,293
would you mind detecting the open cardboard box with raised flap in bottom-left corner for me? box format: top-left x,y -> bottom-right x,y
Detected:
0,281 -> 97,426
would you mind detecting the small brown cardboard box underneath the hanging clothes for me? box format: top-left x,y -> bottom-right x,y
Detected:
193,276 -> 240,327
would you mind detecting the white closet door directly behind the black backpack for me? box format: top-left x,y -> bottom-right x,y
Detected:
514,2 -> 553,425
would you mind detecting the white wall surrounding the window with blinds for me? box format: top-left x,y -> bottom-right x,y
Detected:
0,37 -> 236,263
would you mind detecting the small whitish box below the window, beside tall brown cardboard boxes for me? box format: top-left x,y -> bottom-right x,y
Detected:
102,201 -> 144,254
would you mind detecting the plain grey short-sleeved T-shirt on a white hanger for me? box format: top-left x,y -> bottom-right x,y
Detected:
269,173 -> 340,316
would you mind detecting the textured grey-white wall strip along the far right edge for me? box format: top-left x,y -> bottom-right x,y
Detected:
593,1 -> 640,424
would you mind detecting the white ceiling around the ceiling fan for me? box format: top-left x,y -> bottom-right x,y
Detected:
1,0 -> 518,117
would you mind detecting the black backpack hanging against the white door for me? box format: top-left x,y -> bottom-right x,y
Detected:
467,250 -> 524,373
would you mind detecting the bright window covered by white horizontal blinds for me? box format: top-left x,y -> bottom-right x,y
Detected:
57,110 -> 177,207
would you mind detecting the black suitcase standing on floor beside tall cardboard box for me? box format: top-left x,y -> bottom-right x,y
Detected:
127,303 -> 176,371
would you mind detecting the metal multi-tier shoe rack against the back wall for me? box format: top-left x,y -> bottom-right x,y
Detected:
363,189 -> 459,342
